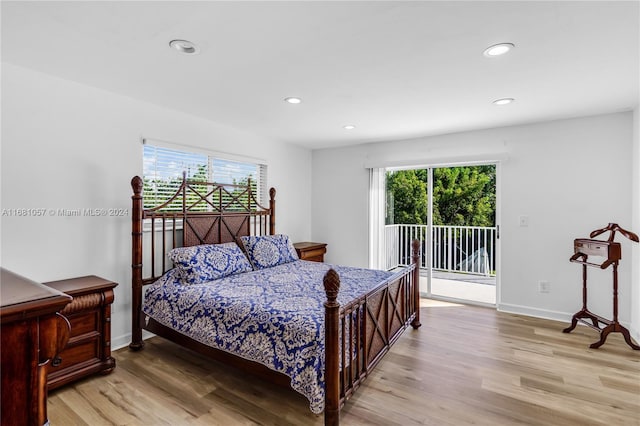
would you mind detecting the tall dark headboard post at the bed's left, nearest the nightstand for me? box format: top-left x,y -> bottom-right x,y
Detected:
129,176 -> 144,351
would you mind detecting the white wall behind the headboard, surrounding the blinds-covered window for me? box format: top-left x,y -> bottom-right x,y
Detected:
1,63 -> 311,347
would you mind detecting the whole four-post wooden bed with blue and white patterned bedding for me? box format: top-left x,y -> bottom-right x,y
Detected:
129,176 -> 420,425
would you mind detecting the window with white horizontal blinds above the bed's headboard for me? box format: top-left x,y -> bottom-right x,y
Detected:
143,140 -> 267,210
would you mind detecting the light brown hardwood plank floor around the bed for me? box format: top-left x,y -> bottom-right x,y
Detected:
48,301 -> 640,426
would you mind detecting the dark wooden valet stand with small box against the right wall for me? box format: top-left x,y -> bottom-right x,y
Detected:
562,223 -> 640,350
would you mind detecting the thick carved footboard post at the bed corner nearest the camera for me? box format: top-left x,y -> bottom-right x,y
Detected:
323,269 -> 340,426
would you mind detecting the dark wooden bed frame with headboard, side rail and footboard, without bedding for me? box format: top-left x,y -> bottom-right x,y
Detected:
129,176 -> 421,425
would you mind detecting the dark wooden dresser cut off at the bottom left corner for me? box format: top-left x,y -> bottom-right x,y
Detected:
0,269 -> 71,426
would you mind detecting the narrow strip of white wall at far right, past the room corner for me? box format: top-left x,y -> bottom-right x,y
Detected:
629,107 -> 640,342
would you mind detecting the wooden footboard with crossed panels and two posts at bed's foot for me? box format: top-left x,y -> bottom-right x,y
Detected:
324,241 -> 421,425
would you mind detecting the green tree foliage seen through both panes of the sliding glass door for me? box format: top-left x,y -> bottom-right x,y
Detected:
387,165 -> 496,226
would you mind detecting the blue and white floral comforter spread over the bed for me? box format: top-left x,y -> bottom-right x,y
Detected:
143,260 -> 394,414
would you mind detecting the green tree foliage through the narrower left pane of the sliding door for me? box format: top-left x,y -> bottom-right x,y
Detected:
387,170 -> 427,225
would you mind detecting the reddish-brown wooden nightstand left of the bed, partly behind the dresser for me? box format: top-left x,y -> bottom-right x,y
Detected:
44,275 -> 118,389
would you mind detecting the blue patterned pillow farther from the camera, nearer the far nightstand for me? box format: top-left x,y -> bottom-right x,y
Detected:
242,234 -> 298,270
